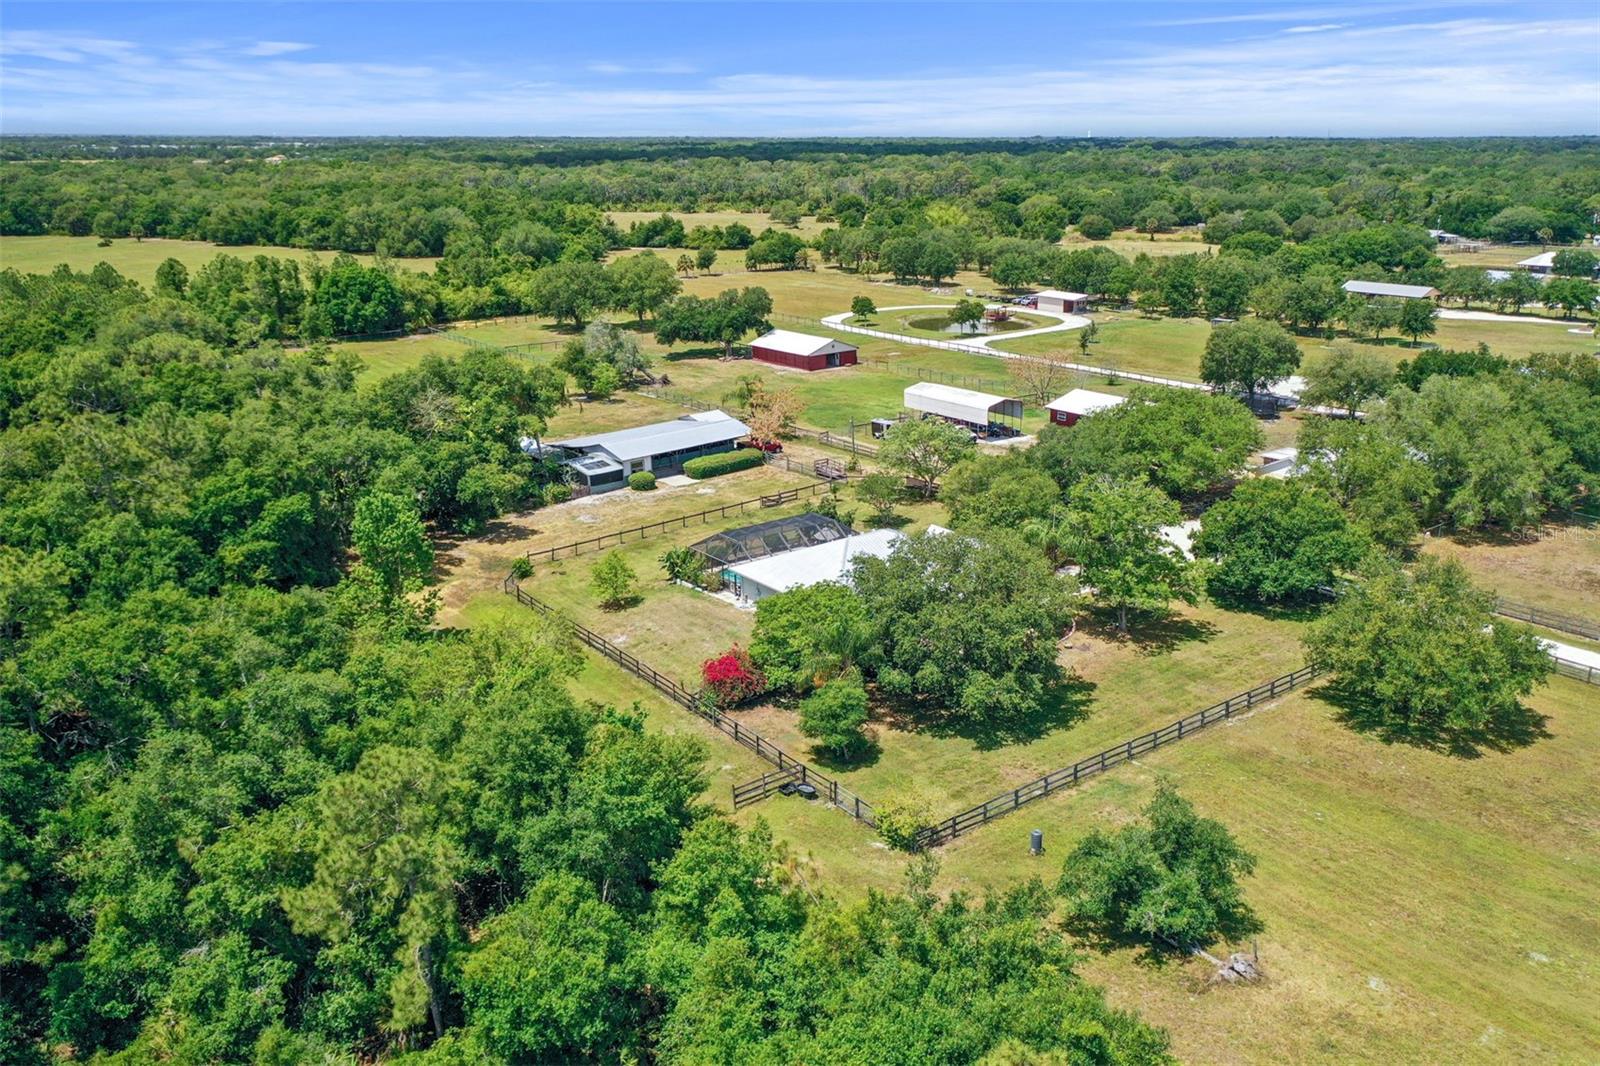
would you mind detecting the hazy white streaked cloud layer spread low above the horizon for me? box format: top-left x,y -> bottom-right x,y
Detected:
0,18 -> 1600,136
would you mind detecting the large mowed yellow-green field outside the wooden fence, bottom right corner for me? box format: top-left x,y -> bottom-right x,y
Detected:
942,679 -> 1600,1063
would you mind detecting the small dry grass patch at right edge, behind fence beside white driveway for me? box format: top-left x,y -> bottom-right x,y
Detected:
1422,523 -> 1600,614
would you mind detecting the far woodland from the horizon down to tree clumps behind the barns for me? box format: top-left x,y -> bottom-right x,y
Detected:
0,139 -> 1600,334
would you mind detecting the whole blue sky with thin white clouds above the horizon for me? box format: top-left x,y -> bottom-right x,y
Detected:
0,0 -> 1600,136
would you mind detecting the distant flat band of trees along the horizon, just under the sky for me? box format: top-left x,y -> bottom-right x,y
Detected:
0,138 -> 1600,249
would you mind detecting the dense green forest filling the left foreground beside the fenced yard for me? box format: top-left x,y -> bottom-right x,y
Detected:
0,259 -> 1166,1063
